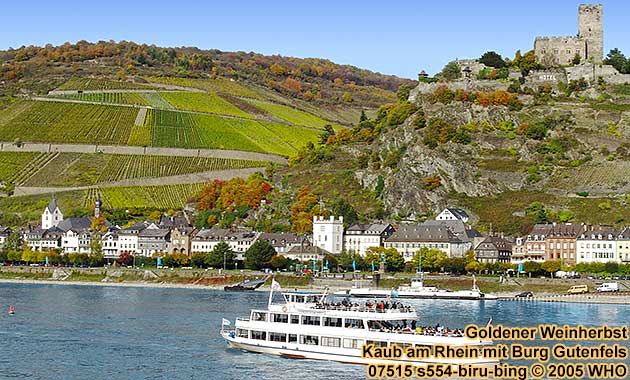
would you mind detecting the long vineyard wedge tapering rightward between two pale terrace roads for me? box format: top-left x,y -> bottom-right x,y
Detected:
25,153 -> 266,187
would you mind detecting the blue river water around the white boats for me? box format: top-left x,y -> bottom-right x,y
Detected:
0,284 -> 630,380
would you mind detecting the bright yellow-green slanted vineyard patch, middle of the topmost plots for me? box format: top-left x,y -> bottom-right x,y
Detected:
160,92 -> 251,118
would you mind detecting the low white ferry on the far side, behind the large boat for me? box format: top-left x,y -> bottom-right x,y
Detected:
334,277 -> 497,300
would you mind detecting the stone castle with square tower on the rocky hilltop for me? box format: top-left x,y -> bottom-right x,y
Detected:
534,4 -> 604,67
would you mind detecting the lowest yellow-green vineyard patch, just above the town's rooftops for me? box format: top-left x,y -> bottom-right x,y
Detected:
84,183 -> 203,209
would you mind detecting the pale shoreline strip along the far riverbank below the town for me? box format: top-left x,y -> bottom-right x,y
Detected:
0,278 -> 630,305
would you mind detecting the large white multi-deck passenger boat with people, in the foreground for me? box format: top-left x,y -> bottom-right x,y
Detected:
221,284 -> 498,365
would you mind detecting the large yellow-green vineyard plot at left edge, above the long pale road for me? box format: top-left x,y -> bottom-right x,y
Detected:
0,102 -> 138,144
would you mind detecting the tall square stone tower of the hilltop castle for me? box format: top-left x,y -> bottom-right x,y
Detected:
578,4 -> 604,64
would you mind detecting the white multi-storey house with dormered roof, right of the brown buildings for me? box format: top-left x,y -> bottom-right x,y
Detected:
576,226 -> 619,264
